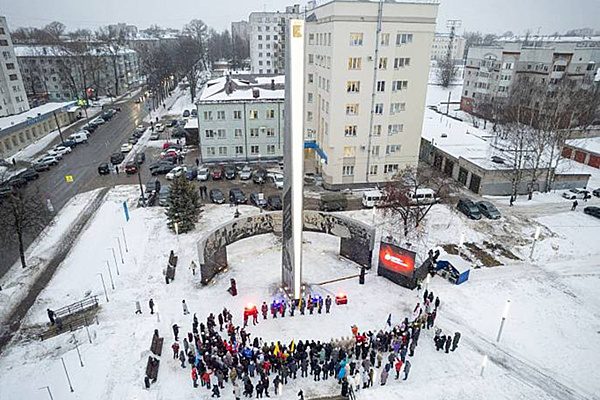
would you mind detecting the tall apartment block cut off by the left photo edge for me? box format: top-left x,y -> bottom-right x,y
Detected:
0,17 -> 29,117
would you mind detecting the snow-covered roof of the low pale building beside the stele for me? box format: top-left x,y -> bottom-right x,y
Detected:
198,75 -> 285,103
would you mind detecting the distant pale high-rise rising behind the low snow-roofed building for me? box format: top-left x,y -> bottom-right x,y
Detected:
248,4 -> 301,74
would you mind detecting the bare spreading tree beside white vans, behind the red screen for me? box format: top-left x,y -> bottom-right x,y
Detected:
380,165 -> 455,238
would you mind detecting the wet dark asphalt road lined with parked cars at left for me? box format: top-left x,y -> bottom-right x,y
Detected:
0,100 -> 149,277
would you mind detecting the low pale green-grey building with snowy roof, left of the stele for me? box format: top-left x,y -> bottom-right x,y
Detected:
195,75 -> 285,162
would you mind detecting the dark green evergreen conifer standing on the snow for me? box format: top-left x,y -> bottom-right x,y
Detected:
166,176 -> 201,233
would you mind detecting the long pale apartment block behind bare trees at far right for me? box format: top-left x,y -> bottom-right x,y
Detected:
461,37 -> 600,113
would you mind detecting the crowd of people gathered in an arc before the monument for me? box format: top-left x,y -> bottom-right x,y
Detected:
162,290 -> 460,400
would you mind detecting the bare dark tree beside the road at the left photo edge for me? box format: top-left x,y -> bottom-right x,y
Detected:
0,184 -> 50,268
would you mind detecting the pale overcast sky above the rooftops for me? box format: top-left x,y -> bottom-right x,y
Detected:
0,0 -> 600,33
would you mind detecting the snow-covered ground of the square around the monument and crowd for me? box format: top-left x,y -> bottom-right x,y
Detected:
0,186 -> 600,400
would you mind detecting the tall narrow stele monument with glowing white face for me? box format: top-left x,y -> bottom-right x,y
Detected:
281,19 -> 304,299
